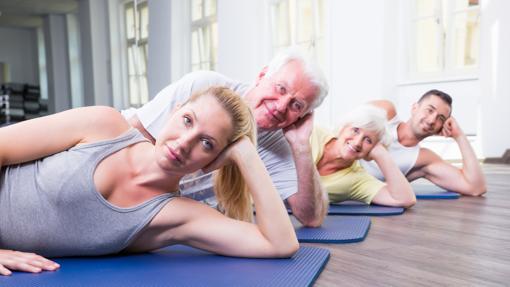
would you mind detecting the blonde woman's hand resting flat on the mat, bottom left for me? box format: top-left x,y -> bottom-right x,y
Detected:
0,249 -> 60,276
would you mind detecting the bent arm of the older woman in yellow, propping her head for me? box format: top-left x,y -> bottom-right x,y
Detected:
370,144 -> 416,208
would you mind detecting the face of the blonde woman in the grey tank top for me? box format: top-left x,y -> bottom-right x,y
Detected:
156,95 -> 233,174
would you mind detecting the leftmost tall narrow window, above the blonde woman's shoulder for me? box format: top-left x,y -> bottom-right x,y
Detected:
124,0 -> 149,107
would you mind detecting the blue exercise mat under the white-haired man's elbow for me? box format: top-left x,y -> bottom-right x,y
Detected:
292,216 -> 370,243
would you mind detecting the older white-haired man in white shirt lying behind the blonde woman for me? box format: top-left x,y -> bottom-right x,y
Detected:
123,48 -> 328,227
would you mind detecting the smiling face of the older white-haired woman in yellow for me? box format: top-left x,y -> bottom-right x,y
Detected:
336,125 -> 378,161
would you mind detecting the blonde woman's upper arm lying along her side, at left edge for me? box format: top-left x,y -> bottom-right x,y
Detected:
0,107 -> 129,166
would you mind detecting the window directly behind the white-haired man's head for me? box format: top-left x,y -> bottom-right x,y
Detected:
270,0 -> 326,67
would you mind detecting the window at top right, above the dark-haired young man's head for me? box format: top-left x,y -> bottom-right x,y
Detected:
410,0 -> 480,78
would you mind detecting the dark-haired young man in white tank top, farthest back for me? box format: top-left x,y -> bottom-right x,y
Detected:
361,90 -> 487,196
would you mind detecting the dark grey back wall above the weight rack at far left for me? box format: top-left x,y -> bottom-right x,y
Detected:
0,28 -> 39,85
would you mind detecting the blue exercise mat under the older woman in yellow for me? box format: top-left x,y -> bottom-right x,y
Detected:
328,201 -> 405,216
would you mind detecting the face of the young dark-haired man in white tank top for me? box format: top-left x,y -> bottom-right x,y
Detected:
411,95 -> 451,139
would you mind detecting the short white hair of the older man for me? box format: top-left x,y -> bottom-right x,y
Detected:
264,46 -> 329,111
